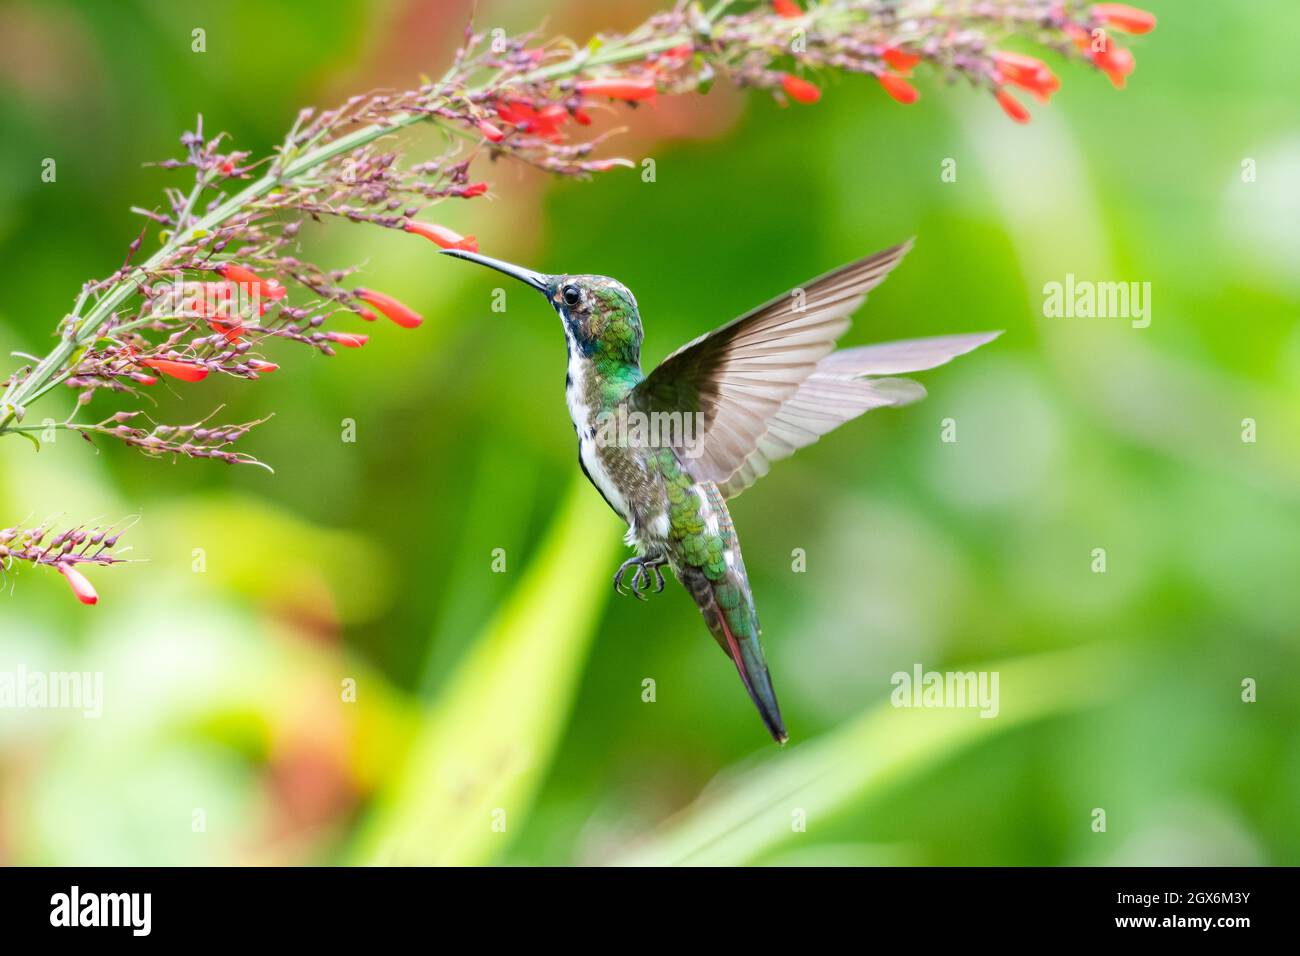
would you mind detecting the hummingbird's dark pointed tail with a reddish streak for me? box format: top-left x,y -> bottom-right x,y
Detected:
673,566 -> 789,744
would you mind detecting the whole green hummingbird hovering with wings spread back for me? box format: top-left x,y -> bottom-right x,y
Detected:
442,239 -> 1001,744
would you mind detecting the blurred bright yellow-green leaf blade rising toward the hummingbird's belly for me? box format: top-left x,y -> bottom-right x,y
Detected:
351,479 -> 619,866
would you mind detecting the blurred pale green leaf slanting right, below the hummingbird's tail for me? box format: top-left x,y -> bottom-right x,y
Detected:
616,648 -> 1126,866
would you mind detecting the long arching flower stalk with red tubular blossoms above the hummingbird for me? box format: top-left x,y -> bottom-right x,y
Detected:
0,0 -> 1154,606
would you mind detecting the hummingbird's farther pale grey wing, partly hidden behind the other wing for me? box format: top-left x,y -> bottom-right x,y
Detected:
718,332 -> 1002,498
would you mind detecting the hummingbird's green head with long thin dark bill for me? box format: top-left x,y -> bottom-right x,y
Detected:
443,248 -> 641,362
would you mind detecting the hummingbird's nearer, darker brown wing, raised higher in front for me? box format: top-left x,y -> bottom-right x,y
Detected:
629,239 -> 911,486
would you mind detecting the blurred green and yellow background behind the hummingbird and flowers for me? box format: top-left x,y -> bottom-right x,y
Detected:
0,0 -> 1300,865
